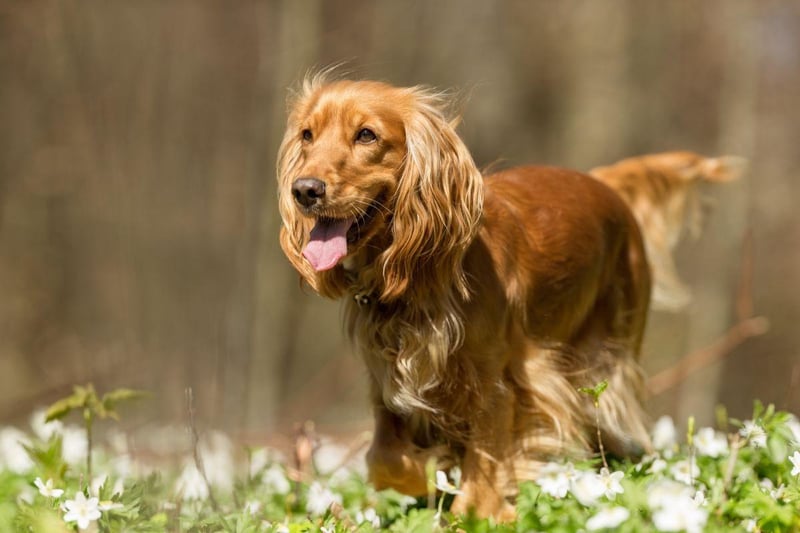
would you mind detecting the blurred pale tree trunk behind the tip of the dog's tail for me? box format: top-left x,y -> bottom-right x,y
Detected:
677,1 -> 760,424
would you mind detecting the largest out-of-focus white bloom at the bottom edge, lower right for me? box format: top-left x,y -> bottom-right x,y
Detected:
647,479 -> 708,533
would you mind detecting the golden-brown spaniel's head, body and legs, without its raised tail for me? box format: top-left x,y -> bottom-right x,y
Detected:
277,76 -> 736,520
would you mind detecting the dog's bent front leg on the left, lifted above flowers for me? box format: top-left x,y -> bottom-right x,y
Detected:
367,404 -> 448,496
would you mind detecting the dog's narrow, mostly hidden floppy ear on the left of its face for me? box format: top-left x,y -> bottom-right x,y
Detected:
277,76 -> 345,298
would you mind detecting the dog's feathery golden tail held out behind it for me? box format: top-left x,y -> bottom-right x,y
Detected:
589,152 -> 747,311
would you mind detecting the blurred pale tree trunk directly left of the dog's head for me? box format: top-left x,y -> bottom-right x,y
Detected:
245,0 -> 322,429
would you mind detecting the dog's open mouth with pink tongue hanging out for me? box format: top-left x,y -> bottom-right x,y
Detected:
303,197 -> 383,272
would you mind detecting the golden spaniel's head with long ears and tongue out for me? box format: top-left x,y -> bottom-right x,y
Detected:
278,77 -> 483,301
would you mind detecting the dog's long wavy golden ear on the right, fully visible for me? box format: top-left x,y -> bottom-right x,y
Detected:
379,88 -> 483,301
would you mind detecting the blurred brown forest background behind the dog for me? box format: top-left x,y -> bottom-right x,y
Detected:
0,0 -> 800,438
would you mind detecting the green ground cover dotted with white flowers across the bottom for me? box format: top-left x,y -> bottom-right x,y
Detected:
0,387 -> 800,533
